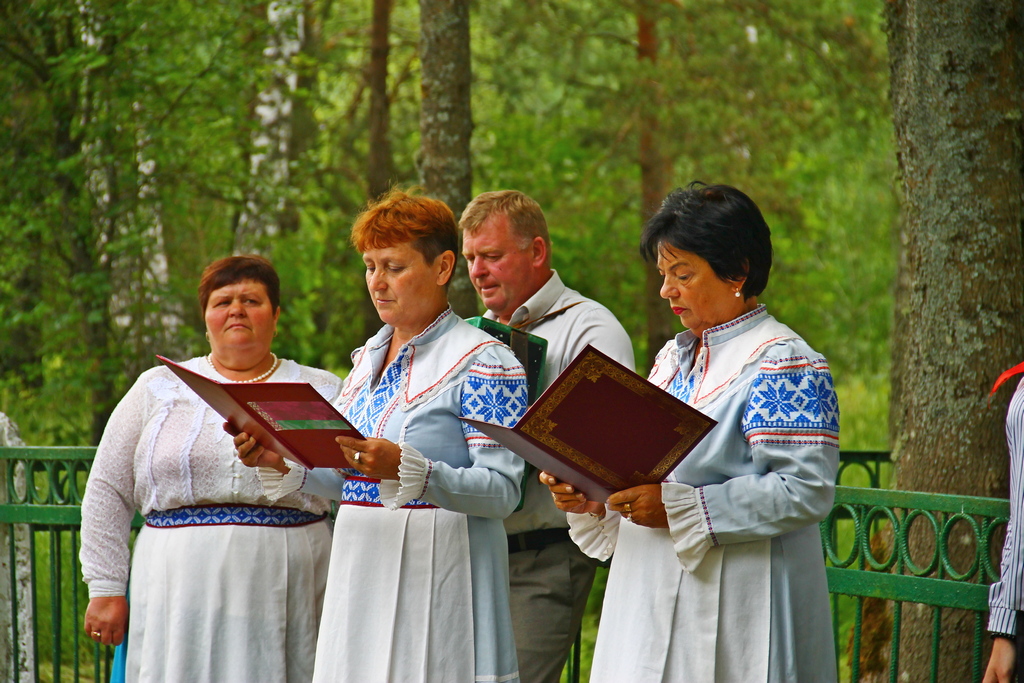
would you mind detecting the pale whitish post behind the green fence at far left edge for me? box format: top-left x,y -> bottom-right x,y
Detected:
0,413 -> 36,681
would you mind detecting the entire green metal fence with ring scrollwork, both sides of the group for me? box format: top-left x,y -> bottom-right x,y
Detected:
0,447 -> 1009,683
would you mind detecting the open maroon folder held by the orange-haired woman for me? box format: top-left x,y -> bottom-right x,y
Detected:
157,355 -> 362,469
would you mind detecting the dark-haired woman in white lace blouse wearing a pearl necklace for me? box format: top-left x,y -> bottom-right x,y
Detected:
81,256 -> 341,683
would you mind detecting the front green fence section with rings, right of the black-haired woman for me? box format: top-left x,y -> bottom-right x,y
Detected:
821,486 -> 1010,681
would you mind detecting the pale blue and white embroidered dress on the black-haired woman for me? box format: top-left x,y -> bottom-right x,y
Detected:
569,306 -> 839,683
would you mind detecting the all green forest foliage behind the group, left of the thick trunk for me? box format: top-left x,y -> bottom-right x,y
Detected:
0,0 -> 896,454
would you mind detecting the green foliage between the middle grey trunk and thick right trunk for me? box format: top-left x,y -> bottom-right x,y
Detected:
474,0 -> 897,436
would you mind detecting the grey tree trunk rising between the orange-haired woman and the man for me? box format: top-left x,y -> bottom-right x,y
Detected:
419,0 -> 478,316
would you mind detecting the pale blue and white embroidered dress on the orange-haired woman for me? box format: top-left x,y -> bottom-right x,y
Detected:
288,309 -> 527,683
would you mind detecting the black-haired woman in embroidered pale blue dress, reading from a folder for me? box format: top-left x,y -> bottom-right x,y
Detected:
541,183 -> 839,683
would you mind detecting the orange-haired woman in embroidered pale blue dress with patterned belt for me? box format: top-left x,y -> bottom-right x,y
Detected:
234,190 -> 526,683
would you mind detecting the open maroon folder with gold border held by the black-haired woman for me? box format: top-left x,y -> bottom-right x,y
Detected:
462,345 -> 718,503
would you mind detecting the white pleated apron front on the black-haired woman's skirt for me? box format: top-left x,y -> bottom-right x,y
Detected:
590,522 -> 771,683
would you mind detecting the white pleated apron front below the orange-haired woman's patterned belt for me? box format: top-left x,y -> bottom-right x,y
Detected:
313,505 -> 475,683
